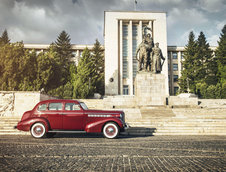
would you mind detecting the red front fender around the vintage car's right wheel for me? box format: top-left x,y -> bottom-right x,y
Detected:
85,118 -> 123,133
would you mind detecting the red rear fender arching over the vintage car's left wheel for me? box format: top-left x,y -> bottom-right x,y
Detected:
17,118 -> 49,132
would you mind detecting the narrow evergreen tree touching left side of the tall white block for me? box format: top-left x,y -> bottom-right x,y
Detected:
92,39 -> 104,95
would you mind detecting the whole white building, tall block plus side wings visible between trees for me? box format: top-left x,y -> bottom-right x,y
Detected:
24,11 -> 216,96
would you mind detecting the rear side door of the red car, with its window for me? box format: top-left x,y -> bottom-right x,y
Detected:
46,102 -> 63,130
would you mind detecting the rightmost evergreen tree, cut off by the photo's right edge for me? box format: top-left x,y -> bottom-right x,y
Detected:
216,25 -> 226,85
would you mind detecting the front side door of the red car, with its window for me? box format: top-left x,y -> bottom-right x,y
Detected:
63,102 -> 86,130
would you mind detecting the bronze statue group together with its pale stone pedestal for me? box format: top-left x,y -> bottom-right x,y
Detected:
135,28 -> 167,106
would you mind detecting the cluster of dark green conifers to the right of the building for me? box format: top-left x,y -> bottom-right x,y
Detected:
179,26 -> 226,98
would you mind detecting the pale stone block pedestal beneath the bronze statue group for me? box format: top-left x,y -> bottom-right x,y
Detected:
135,72 -> 166,106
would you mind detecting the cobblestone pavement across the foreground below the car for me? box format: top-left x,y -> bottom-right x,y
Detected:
0,134 -> 226,172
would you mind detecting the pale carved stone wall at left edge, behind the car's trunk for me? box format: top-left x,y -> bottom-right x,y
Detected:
0,91 -> 54,117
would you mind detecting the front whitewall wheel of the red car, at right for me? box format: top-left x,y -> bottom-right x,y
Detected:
103,122 -> 119,139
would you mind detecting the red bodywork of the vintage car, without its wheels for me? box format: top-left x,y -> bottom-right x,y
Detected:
17,99 -> 125,132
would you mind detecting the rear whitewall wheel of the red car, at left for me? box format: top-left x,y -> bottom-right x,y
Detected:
31,122 -> 46,138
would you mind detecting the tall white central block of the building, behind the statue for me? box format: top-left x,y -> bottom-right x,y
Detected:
104,11 -> 169,95
